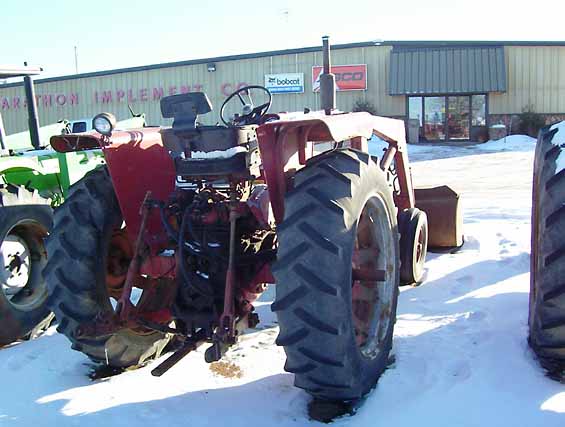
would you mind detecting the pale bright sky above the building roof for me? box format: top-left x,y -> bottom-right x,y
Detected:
4,0 -> 565,77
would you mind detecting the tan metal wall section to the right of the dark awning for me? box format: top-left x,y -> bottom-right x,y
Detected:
489,46 -> 565,114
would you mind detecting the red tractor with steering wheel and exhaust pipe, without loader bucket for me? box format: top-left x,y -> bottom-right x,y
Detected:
44,38 -> 456,412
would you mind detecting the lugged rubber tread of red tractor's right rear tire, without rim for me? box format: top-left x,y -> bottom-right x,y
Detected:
272,149 -> 398,400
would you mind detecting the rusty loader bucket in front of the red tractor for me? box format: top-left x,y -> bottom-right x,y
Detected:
414,185 -> 463,250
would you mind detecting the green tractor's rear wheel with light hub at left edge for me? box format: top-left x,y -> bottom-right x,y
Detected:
0,184 -> 53,345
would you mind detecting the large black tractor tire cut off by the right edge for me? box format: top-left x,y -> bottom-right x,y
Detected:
529,122 -> 565,380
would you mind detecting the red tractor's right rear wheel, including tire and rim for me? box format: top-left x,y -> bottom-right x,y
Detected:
272,150 -> 399,402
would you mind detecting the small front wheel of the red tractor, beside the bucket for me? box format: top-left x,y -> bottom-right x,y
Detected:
398,208 -> 428,285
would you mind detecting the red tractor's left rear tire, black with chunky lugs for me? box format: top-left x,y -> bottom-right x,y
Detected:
44,168 -> 169,368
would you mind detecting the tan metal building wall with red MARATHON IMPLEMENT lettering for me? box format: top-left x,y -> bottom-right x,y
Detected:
0,46 -> 405,134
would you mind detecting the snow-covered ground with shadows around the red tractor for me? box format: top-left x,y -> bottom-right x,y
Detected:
0,136 -> 565,427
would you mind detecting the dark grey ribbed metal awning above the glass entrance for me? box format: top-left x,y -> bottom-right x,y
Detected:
389,46 -> 506,95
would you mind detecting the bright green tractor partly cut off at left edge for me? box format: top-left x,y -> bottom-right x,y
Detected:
0,66 -> 141,346
